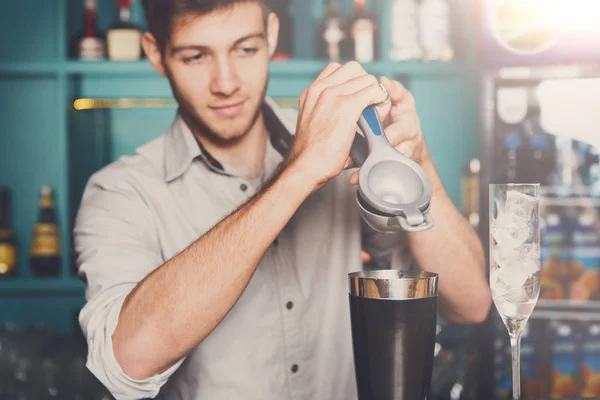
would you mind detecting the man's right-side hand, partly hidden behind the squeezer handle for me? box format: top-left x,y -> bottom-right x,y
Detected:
350,77 -> 431,185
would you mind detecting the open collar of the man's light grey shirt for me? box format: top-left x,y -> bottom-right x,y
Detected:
164,97 -> 296,182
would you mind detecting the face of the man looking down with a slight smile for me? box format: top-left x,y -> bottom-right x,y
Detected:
144,1 -> 279,145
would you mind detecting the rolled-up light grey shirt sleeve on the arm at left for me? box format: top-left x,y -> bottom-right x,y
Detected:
74,168 -> 183,400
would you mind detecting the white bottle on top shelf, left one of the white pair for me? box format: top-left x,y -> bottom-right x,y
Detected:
390,0 -> 423,61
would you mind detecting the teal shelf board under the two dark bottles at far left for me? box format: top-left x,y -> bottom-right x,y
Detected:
0,277 -> 84,297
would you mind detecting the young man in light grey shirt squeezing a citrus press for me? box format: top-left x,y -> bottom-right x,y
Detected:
74,0 -> 490,400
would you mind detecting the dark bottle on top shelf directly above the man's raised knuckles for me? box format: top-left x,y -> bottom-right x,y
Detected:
321,0 -> 350,61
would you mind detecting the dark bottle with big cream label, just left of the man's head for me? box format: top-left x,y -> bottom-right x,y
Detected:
106,0 -> 142,61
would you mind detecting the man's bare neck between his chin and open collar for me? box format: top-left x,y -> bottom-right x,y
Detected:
194,113 -> 269,179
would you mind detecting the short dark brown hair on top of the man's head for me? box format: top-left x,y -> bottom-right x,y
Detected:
142,0 -> 270,51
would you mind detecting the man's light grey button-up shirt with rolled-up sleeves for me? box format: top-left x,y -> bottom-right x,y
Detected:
74,98 -> 412,400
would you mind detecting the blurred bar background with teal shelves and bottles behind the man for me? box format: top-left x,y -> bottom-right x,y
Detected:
0,0 -> 600,400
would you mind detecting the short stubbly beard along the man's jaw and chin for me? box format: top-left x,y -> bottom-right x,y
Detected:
165,68 -> 269,147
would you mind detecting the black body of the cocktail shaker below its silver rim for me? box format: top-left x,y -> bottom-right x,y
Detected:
349,295 -> 437,400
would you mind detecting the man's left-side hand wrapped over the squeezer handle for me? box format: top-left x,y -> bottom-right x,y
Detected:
288,61 -> 389,189
